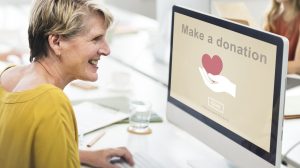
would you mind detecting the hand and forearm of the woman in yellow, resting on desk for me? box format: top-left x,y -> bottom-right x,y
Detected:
79,147 -> 134,168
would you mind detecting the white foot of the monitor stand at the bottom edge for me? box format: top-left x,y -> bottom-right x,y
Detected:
186,157 -> 237,168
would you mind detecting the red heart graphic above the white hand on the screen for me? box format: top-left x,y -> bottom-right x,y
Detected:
202,54 -> 223,75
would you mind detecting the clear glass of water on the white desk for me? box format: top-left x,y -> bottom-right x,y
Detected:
128,100 -> 151,134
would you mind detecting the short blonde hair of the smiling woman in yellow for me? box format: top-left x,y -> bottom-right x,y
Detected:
28,0 -> 113,61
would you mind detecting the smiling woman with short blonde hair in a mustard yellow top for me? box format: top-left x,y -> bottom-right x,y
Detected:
0,0 -> 133,168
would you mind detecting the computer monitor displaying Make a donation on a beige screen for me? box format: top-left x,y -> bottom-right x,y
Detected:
167,6 -> 288,168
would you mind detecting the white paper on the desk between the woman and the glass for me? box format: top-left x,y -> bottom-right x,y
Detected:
73,102 -> 128,134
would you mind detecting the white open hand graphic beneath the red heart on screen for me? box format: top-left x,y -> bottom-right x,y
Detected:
199,67 -> 236,97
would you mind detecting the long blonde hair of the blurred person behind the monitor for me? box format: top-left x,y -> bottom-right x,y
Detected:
264,0 -> 300,31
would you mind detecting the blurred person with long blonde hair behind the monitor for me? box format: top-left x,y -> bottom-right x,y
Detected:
265,0 -> 300,74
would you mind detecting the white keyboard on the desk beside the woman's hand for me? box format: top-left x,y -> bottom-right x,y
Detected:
114,152 -> 169,168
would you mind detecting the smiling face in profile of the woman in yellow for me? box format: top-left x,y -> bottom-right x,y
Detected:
60,14 -> 110,81
